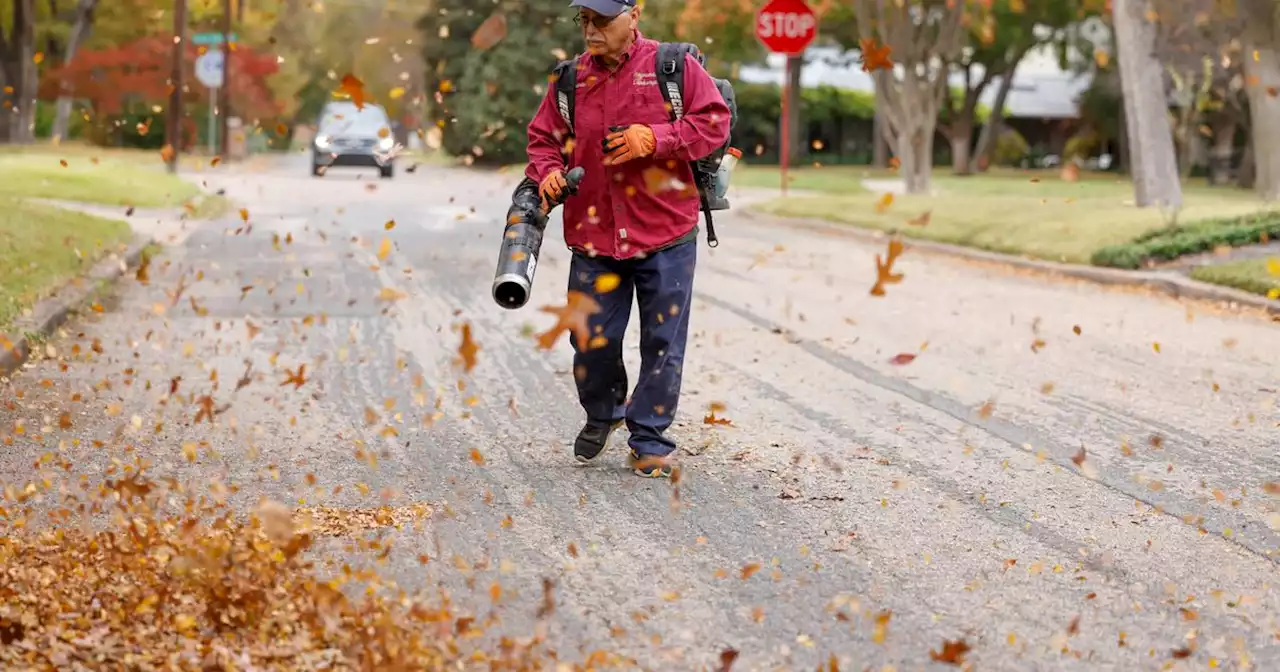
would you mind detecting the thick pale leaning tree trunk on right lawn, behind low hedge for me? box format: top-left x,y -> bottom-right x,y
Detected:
1111,0 -> 1182,207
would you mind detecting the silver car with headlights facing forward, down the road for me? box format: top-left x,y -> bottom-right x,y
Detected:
311,101 -> 396,179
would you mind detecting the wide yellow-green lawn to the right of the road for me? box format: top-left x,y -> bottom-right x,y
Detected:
752,166 -> 1275,264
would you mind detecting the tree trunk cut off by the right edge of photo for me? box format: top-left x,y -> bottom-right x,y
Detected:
1240,0 -> 1280,201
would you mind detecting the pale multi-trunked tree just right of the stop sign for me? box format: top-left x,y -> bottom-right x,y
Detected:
854,0 -> 964,193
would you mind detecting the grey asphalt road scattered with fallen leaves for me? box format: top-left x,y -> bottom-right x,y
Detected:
0,157 -> 1280,671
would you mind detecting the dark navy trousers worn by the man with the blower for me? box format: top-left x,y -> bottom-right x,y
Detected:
568,239 -> 698,456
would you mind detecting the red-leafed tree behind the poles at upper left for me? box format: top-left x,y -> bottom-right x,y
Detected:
40,36 -> 282,144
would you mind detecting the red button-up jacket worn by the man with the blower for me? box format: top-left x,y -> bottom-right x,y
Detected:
525,32 -> 730,259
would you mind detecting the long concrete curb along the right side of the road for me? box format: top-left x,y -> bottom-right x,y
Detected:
744,210 -> 1280,321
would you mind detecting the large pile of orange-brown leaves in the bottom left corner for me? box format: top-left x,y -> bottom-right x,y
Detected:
0,467 -> 534,669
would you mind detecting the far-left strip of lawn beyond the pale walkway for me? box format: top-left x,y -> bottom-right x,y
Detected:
0,145 -> 200,207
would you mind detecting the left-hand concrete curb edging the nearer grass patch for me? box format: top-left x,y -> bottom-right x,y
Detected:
0,236 -> 155,376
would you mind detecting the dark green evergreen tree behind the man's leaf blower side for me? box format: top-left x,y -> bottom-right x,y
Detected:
417,0 -> 582,164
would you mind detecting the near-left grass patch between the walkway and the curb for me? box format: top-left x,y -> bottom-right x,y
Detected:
0,196 -> 131,329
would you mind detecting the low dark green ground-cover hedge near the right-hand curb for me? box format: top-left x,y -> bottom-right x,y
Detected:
1089,211 -> 1280,269
